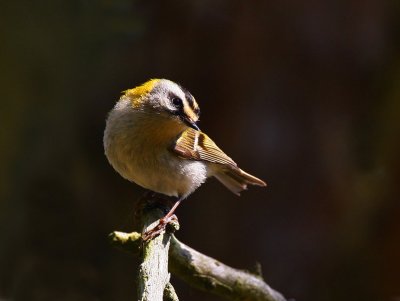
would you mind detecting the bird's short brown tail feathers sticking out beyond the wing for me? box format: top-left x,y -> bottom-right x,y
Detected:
215,168 -> 267,195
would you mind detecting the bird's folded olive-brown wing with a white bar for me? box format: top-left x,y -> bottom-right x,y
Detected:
172,128 -> 237,168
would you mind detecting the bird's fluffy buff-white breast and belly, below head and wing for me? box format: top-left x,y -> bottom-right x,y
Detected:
104,99 -> 207,198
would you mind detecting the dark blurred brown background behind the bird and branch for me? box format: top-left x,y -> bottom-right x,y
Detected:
0,0 -> 400,301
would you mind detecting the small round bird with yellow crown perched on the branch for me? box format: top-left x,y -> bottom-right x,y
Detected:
104,79 -> 266,240
